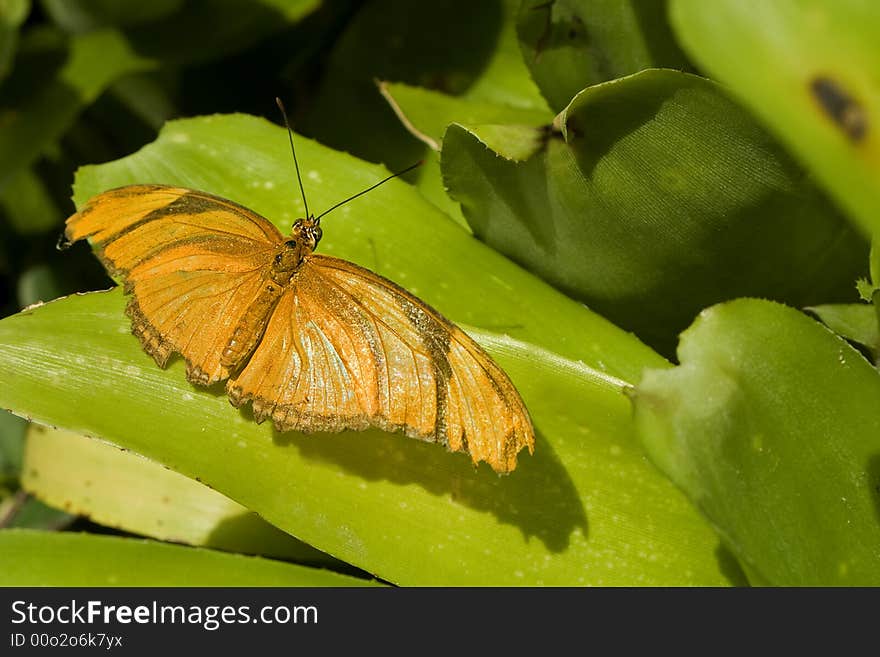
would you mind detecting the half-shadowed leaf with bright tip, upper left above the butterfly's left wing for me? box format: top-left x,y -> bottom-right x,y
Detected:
0,31 -> 150,191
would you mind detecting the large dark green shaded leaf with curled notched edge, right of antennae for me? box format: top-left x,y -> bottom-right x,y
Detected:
441,70 -> 867,353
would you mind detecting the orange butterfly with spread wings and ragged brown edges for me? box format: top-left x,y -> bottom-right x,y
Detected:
65,118 -> 535,472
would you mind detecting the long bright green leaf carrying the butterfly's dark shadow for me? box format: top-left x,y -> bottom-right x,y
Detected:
0,290 -> 725,585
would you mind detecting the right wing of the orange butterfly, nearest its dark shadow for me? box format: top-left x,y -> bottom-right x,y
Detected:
227,254 -> 534,472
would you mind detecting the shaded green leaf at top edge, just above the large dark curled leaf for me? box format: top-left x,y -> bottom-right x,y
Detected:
517,0 -> 687,111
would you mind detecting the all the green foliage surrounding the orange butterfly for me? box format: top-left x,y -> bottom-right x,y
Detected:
0,0 -> 880,585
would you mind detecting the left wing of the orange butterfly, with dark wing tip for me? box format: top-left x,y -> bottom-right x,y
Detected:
66,185 -> 283,385
